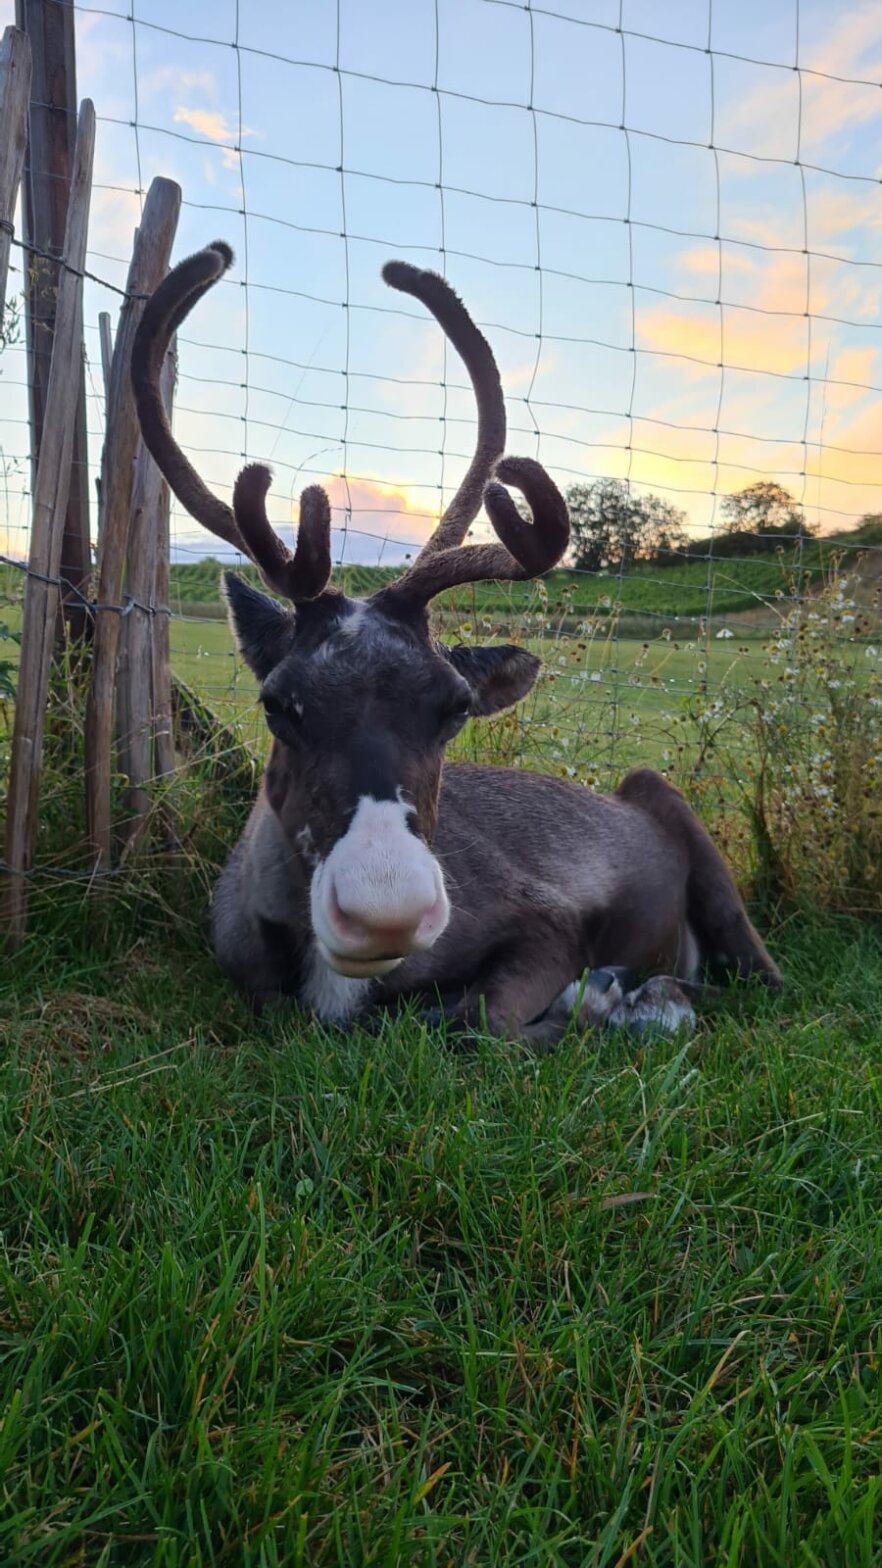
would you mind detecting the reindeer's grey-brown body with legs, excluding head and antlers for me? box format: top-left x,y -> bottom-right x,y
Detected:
213,764 -> 780,1044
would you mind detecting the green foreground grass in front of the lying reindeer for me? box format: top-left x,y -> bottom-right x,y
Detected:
0,896 -> 882,1568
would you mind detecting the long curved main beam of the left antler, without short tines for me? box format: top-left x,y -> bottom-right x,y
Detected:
132,240 -> 248,555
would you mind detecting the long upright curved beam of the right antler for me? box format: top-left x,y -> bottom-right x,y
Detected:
383,262 -> 505,561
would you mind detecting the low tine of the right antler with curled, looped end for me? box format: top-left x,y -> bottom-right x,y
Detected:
375,458 -> 570,608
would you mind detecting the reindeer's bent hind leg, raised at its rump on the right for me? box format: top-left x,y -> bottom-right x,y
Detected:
617,768 -> 783,986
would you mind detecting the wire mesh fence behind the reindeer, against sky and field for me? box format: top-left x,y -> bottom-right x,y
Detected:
0,0 -> 882,890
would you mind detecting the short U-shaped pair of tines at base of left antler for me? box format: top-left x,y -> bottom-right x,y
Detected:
232,463 -> 331,604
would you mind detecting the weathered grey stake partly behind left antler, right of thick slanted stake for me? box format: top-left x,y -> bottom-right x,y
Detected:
118,345 -> 174,850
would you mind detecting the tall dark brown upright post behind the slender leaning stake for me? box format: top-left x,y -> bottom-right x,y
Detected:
16,0 -> 91,638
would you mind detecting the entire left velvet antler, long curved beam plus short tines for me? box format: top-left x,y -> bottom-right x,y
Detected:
132,240 -> 331,604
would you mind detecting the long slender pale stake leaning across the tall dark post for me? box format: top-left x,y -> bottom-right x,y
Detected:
3,99 -> 94,946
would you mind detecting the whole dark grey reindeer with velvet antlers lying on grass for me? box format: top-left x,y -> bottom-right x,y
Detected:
132,241 -> 780,1044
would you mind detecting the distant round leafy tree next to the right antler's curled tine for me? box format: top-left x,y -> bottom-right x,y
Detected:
567,480 -> 686,572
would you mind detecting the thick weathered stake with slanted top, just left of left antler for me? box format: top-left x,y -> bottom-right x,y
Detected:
86,177 -> 180,869
